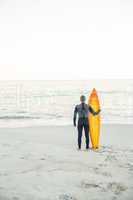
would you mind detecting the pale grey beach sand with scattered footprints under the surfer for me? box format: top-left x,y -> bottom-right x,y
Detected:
0,125 -> 133,200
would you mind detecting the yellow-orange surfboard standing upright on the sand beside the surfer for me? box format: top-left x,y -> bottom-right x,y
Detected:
88,88 -> 100,149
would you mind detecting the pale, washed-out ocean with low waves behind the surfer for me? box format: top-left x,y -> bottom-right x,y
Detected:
0,80 -> 133,127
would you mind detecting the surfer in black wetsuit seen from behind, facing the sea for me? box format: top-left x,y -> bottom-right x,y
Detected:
73,95 -> 100,150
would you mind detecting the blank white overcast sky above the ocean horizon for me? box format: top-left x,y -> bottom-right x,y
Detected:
0,0 -> 133,80
